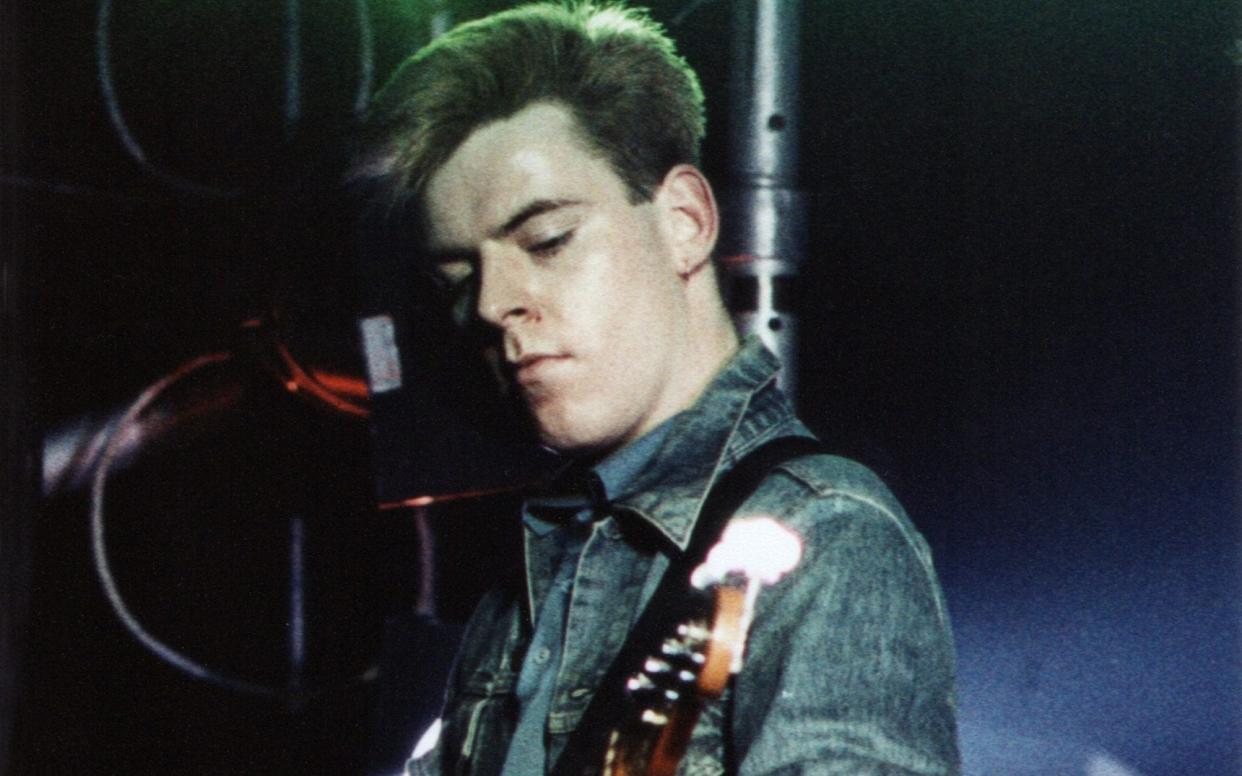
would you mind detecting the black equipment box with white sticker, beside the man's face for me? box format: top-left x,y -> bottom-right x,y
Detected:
358,212 -> 559,509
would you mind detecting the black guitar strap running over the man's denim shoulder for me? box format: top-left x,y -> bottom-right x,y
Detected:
551,437 -> 827,776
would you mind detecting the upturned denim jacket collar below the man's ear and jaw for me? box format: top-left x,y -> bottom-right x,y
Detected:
614,336 -> 806,550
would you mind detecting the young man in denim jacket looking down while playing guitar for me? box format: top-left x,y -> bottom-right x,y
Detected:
358,4 -> 958,776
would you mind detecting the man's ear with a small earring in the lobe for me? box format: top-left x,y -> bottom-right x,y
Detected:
655,164 -> 720,279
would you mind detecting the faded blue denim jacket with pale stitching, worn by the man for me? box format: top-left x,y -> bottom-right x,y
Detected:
409,339 -> 960,776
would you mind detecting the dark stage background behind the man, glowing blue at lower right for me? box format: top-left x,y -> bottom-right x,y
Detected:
0,0 -> 1242,776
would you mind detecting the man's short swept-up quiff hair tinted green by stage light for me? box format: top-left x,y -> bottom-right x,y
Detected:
351,2 -> 704,207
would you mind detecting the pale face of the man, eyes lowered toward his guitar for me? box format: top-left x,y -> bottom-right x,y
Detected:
424,103 -> 699,453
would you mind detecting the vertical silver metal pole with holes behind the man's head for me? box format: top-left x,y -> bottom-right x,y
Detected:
720,0 -> 806,396
